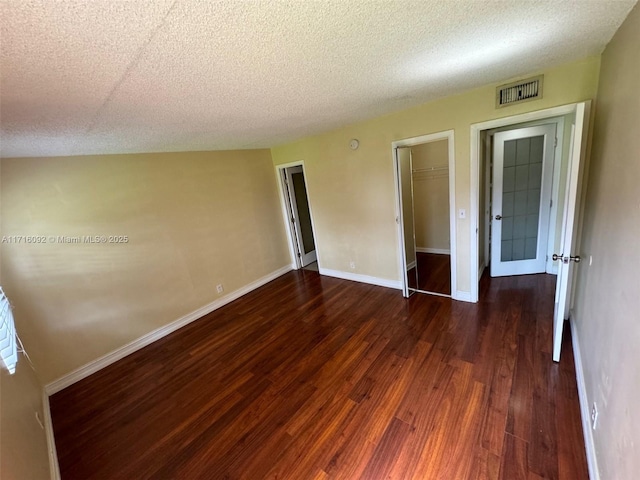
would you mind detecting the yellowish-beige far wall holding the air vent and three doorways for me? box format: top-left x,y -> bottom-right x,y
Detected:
271,57 -> 600,292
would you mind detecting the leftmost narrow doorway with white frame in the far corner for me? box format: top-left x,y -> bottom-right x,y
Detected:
277,163 -> 318,270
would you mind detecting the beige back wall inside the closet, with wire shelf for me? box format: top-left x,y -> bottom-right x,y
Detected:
411,140 -> 450,250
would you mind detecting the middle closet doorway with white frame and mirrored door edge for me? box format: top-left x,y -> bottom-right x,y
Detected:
392,131 -> 456,298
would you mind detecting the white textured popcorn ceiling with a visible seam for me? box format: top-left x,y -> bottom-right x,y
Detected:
0,0 -> 636,157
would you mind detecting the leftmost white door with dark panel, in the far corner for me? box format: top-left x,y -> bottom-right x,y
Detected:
284,166 -> 317,267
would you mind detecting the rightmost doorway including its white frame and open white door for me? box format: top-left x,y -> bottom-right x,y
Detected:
471,102 -> 590,362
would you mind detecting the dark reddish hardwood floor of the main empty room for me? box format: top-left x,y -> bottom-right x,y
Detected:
51,271 -> 588,480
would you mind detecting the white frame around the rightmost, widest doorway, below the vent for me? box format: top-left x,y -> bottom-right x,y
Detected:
469,101 -> 589,302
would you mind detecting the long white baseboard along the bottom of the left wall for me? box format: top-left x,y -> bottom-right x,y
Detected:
44,265 -> 291,395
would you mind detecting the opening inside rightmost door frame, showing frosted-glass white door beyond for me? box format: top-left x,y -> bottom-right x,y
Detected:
478,113 -> 575,278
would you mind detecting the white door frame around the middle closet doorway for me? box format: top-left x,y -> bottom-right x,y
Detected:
391,130 -> 458,300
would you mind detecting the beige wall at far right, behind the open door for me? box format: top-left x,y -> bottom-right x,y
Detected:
573,2 -> 640,480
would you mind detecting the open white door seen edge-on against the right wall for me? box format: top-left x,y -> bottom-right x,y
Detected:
553,102 -> 590,362
